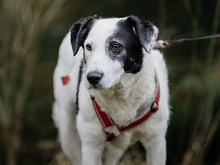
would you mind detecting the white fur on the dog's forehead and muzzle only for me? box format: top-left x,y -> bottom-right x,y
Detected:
84,19 -> 124,89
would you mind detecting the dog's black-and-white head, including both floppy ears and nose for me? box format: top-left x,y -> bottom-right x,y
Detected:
71,16 -> 158,89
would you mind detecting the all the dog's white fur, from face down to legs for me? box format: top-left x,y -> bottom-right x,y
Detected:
53,19 -> 169,165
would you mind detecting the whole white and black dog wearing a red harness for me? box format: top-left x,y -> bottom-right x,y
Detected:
53,16 -> 169,165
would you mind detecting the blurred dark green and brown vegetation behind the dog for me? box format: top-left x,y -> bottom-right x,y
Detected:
0,0 -> 220,165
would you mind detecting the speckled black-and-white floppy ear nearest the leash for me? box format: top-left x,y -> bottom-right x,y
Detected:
127,16 -> 158,53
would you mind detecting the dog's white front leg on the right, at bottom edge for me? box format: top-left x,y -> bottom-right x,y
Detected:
144,136 -> 166,165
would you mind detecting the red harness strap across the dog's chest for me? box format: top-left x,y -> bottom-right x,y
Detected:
91,78 -> 160,141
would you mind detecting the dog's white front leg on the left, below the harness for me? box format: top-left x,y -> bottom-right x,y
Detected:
77,114 -> 105,165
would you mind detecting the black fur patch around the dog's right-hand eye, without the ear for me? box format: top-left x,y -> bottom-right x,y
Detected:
106,20 -> 143,73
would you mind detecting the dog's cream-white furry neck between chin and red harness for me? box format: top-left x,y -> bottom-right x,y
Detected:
91,55 -> 156,126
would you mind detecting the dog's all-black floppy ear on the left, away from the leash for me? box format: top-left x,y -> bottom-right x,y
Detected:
70,15 -> 100,56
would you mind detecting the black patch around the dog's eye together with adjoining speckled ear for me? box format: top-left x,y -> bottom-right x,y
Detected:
106,16 -> 157,73
